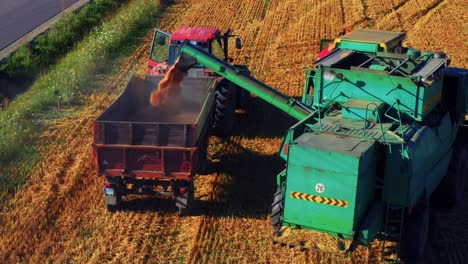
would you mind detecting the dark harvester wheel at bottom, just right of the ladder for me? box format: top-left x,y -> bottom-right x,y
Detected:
400,202 -> 429,263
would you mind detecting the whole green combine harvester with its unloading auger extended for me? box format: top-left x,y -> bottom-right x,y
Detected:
176,30 -> 468,260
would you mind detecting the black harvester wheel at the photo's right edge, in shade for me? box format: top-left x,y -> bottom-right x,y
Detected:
432,145 -> 468,209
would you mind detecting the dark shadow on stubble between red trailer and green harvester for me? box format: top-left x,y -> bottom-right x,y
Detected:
193,98 -> 296,218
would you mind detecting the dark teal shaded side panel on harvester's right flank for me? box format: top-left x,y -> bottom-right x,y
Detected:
383,113 -> 458,207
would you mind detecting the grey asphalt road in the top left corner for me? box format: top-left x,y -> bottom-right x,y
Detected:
0,0 -> 78,50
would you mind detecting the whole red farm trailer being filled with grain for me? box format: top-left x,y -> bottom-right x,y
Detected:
94,76 -> 217,213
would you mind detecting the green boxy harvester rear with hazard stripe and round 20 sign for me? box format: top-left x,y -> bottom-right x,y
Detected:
283,133 -> 376,238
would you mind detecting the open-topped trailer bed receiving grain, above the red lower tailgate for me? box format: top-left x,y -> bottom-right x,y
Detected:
95,76 -> 215,147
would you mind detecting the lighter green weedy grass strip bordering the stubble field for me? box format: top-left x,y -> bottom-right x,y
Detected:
0,0 -> 161,204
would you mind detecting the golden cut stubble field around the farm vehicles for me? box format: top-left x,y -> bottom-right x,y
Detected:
0,0 -> 468,263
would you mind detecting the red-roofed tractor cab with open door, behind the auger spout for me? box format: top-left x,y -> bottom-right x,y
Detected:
147,27 -> 242,76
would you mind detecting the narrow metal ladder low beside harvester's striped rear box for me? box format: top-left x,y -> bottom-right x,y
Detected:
381,203 -> 405,263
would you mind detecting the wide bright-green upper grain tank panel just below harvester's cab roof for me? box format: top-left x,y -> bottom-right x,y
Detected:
314,67 -> 442,121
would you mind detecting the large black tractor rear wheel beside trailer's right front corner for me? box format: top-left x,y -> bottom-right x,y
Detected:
213,81 -> 236,137
